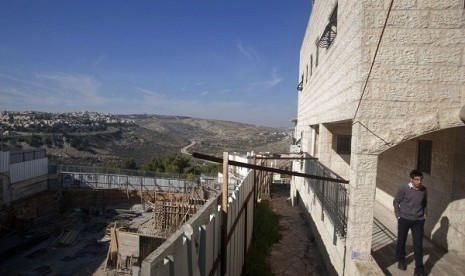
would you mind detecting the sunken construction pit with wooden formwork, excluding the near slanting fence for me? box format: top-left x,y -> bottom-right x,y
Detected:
0,150 -> 219,275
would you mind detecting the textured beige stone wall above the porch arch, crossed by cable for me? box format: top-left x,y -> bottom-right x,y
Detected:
358,0 -> 465,151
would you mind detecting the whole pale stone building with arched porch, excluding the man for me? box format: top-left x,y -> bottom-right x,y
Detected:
291,0 -> 465,275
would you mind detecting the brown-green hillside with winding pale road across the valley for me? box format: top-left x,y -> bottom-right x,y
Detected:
32,115 -> 292,165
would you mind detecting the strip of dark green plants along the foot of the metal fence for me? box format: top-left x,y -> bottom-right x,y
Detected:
245,201 -> 281,276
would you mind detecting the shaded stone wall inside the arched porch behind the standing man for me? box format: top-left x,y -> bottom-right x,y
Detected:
376,128 -> 465,254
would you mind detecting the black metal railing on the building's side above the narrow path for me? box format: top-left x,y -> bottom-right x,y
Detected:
306,160 -> 349,238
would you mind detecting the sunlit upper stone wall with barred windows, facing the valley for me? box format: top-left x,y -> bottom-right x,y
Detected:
297,0 -> 363,140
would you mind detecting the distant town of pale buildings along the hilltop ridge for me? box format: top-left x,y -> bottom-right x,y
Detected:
0,111 -> 135,136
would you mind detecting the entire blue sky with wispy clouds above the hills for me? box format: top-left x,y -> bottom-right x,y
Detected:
0,0 -> 311,127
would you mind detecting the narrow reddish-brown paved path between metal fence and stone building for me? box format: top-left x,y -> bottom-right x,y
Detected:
264,185 -> 327,276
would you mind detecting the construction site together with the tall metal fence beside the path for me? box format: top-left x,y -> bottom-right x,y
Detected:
0,149 -> 292,275
